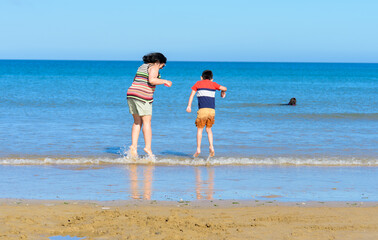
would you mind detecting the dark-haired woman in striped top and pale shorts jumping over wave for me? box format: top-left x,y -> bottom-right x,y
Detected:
127,52 -> 172,157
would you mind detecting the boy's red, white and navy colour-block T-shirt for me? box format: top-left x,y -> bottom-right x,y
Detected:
192,79 -> 220,109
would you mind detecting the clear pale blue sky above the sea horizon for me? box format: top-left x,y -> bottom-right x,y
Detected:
0,0 -> 378,62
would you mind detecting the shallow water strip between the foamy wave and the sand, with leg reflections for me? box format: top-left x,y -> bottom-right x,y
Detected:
0,165 -> 378,202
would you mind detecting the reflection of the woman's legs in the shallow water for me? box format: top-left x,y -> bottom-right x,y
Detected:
129,165 -> 154,200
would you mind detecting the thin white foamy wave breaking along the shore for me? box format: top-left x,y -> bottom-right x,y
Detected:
0,156 -> 378,166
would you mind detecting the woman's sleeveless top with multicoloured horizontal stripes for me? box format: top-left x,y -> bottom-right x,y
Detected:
127,63 -> 160,103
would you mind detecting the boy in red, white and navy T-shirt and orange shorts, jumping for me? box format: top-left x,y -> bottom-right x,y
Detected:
186,70 -> 227,157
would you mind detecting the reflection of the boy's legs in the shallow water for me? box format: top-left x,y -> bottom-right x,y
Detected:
195,167 -> 214,200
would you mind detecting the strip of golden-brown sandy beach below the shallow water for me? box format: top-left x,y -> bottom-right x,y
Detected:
0,199 -> 378,240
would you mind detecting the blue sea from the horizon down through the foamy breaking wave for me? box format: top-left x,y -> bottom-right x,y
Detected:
0,60 -> 378,166
